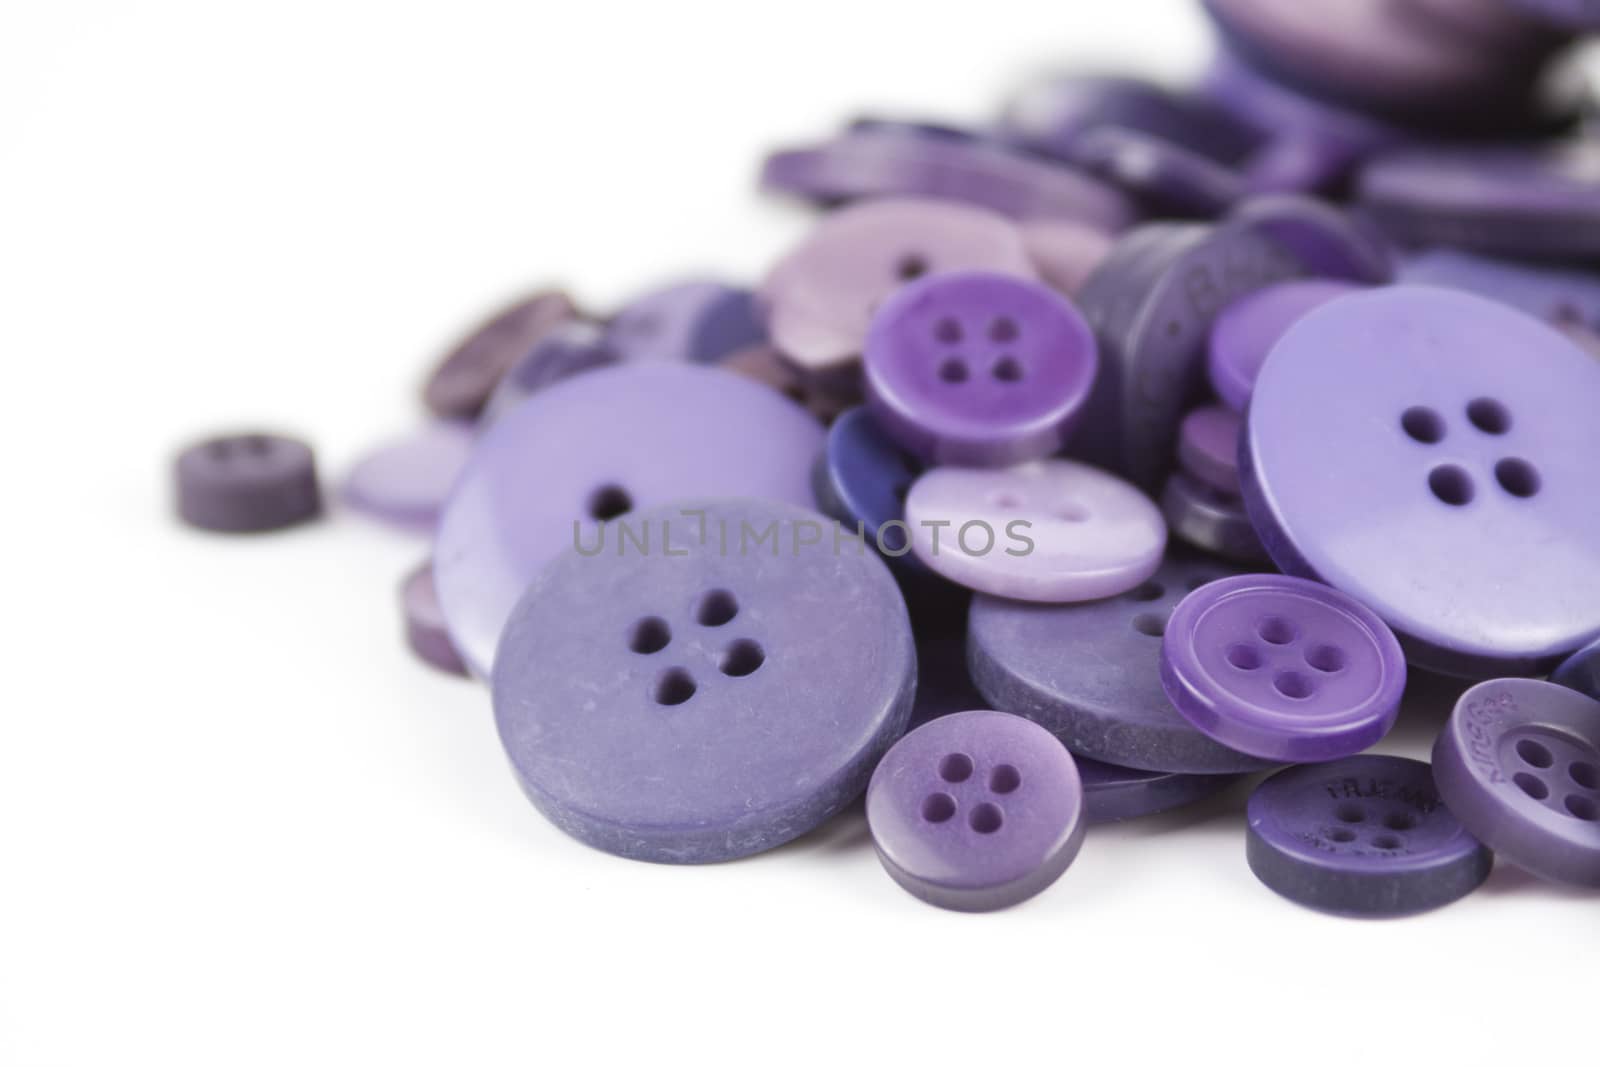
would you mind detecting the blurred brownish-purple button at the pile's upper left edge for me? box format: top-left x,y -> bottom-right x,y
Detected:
422,293 -> 578,419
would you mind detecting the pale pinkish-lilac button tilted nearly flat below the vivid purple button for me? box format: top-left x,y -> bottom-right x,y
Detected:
906,459 -> 1166,603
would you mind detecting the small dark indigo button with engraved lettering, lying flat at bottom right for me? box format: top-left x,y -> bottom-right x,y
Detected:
1245,755 -> 1494,918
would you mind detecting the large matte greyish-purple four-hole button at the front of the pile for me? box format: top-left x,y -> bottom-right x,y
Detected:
493,501 -> 917,864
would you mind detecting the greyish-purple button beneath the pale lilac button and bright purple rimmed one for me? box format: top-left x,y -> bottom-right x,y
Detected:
966,552 -> 1270,774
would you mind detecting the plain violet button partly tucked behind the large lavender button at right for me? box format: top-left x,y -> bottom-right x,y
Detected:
1206,278 -> 1365,412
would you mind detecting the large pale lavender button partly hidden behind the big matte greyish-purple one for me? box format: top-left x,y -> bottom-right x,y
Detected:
434,363 -> 822,675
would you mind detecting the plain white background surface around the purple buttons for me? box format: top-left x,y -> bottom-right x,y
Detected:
0,0 -> 1600,1067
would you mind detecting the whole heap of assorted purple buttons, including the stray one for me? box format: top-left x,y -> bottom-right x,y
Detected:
176,0 -> 1600,917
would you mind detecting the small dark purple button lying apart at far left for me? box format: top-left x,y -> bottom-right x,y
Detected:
173,434 -> 322,533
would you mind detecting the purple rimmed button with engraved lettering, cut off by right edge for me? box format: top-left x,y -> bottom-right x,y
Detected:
1434,678 -> 1600,888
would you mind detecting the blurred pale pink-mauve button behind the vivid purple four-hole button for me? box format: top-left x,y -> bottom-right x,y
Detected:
758,198 -> 1038,371
